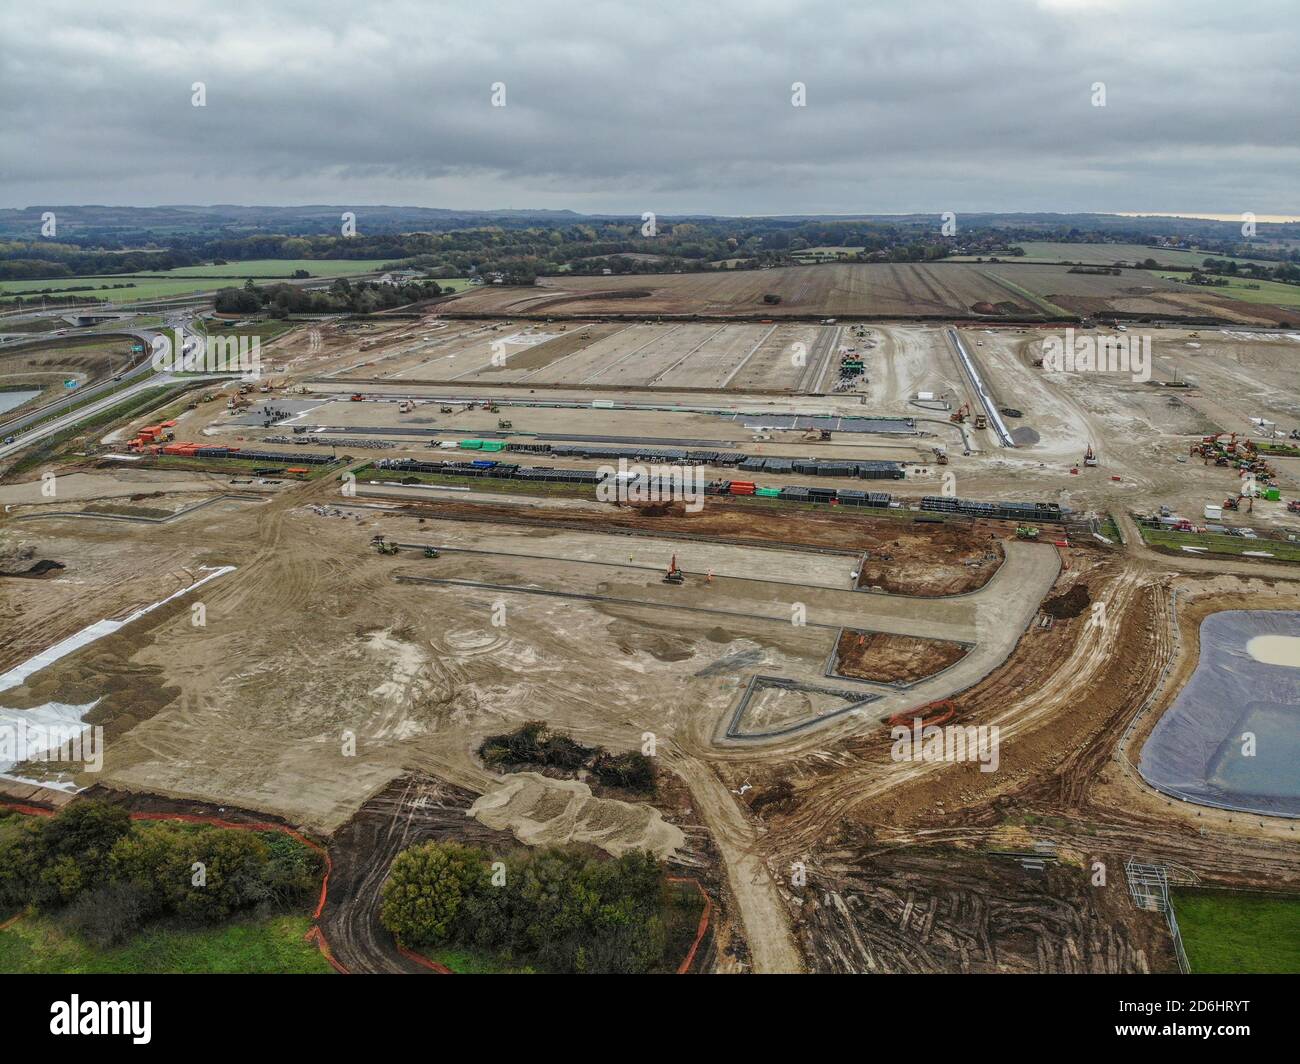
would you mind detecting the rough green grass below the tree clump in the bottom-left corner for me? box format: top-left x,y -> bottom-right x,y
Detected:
0,916 -> 335,974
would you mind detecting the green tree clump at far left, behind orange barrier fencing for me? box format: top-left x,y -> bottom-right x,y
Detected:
0,801 -> 321,947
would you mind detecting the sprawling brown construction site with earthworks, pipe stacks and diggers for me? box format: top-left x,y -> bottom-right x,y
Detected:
0,303 -> 1300,973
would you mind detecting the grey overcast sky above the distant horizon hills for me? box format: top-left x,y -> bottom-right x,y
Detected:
0,0 -> 1300,215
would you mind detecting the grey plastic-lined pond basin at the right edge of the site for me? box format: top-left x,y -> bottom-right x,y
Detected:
1138,610 -> 1300,817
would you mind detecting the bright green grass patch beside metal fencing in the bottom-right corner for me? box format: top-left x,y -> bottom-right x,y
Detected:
1173,890 -> 1300,974
